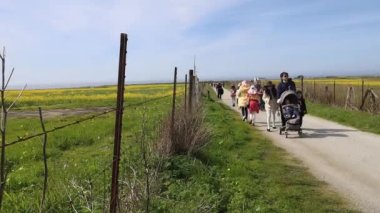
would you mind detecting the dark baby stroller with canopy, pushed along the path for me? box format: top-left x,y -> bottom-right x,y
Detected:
279,90 -> 302,138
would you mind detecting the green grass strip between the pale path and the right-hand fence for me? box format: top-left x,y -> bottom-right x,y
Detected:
307,102 -> 380,134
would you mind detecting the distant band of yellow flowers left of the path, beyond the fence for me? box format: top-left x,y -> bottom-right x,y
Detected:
6,84 -> 184,108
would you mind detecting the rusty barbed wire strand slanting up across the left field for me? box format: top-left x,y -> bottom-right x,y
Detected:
0,93 -> 183,148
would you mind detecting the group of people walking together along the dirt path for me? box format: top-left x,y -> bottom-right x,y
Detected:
226,72 -> 307,132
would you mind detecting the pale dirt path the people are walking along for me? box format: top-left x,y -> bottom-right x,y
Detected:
218,90 -> 380,212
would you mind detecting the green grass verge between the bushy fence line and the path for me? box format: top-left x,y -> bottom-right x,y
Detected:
154,95 -> 355,212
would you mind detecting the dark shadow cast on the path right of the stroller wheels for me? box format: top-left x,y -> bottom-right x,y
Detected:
302,128 -> 357,138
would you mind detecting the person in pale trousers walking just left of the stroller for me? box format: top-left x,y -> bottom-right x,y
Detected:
263,81 -> 278,132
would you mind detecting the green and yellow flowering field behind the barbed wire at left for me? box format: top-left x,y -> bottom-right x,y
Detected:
2,84 -> 184,212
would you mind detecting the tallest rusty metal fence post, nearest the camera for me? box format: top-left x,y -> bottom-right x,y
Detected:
110,33 -> 128,213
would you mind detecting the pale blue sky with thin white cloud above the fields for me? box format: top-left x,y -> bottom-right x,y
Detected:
0,0 -> 380,85
